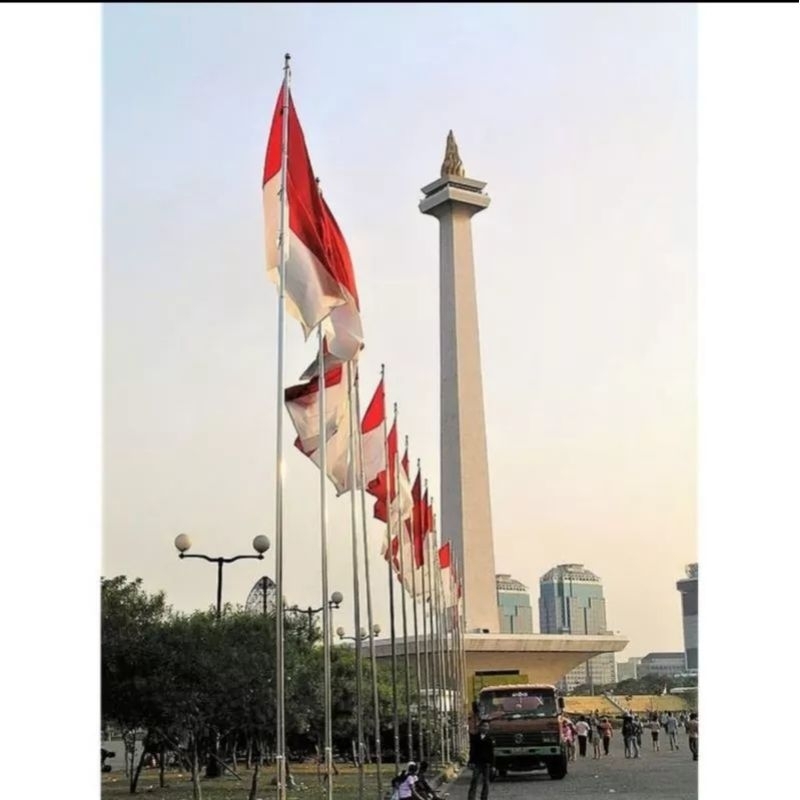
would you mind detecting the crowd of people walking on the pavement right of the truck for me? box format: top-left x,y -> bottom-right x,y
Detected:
561,711 -> 699,761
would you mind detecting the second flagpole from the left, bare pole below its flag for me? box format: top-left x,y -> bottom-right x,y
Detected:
317,325 -> 333,800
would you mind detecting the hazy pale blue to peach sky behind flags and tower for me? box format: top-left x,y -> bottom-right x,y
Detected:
103,4 -> 696,660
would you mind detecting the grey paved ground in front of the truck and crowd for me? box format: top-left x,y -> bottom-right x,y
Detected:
445,739 -> 699,800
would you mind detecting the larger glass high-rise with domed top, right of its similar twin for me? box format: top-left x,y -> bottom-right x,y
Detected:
539,564 -> 616,692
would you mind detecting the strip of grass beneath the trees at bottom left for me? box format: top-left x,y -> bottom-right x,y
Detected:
100,764 -> 456,800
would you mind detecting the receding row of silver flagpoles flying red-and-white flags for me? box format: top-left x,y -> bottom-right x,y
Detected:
262,54 -> 466,800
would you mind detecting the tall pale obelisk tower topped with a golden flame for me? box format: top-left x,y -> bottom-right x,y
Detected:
419,131 -> 500,633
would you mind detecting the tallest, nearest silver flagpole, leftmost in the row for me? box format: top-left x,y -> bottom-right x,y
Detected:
275,53 -> 292,800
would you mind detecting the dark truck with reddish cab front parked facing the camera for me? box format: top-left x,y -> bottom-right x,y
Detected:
477,684 -> 567,780
